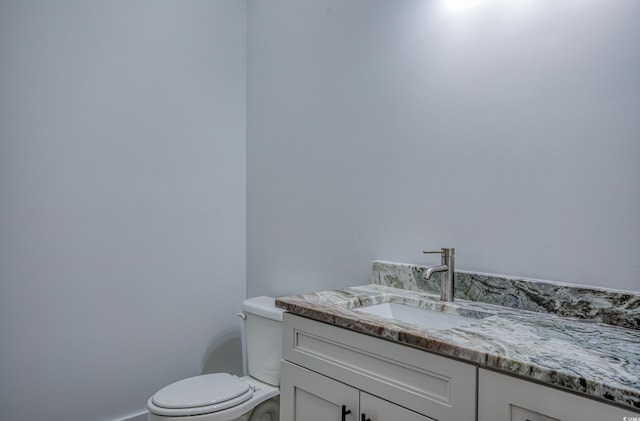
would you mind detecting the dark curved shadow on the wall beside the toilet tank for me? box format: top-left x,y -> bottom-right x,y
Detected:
202,327 -> 244,376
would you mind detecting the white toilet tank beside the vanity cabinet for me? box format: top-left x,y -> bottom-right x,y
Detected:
242,297 -> 283,386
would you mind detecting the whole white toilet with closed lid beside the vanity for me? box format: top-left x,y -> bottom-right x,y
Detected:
147,297 -> 283,421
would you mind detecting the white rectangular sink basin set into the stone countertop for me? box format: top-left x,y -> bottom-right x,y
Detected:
354,302 -> 489,329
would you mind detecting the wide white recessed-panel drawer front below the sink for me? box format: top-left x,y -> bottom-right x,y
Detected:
282,313 -> 477,421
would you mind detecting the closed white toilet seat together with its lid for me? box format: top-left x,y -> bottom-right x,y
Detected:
147,373 -> 254,417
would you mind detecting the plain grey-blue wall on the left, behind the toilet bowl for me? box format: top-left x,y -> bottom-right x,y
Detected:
0,0 -> 246,421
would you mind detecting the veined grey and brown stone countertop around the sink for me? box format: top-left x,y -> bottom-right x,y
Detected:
276,262 -> 640,411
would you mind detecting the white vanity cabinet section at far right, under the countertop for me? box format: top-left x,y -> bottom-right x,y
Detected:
478,368 -> 640,421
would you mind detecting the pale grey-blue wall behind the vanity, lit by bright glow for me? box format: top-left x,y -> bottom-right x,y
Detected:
247,0 -> 640,296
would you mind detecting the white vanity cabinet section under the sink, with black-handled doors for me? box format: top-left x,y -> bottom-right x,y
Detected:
280,313 -> 477,421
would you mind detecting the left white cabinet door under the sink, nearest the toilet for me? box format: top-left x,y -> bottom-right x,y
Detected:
280,361 -> 360,421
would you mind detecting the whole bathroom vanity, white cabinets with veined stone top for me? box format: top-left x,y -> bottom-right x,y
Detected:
277,263 -> 640,421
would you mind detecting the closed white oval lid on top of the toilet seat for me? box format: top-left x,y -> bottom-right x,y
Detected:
151,373 -> 253,409
